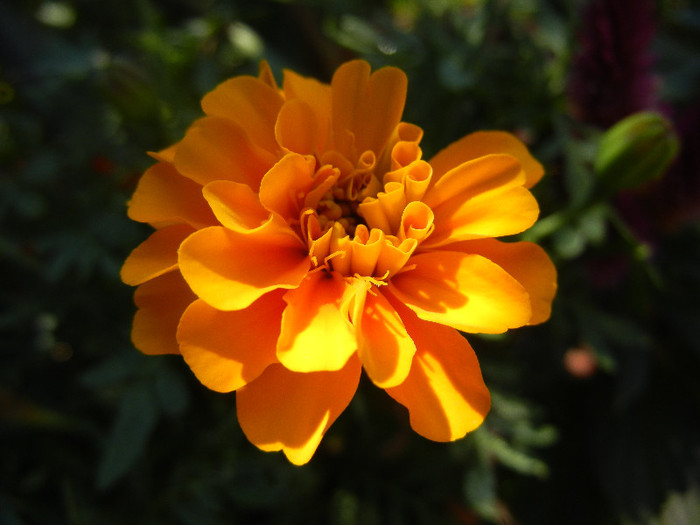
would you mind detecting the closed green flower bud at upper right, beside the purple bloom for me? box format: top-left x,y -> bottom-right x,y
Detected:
594,112 -> 679,194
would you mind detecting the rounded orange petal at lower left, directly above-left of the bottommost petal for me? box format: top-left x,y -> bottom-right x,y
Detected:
177,291 -> 285,392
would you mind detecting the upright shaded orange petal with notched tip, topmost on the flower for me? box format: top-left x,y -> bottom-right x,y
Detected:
331,60 -> 407,155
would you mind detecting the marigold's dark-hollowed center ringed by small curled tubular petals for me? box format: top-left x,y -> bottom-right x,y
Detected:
300,147 -> 433,282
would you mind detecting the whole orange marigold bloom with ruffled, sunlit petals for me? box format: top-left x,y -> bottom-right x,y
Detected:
122,60 -> 556,464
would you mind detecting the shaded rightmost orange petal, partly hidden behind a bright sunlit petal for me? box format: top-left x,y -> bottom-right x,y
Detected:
438,239 -> 557,325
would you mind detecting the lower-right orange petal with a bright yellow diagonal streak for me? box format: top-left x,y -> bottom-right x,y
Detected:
386,296 -> 491,441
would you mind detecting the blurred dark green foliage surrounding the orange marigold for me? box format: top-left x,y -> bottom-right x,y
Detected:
0,0 -> 700,525
